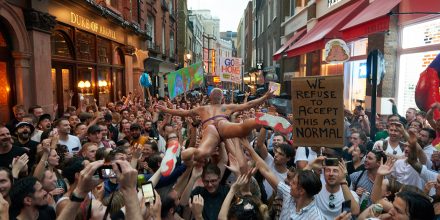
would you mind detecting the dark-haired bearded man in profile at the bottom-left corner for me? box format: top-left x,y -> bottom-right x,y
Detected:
9,176 -> 56,220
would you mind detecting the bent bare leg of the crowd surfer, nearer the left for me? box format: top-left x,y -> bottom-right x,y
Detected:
182,125 -> 220,161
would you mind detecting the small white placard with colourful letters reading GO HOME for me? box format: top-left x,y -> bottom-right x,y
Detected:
218,57 -> 241,83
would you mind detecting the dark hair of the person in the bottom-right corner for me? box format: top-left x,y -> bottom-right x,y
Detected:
396,191 -> 435,220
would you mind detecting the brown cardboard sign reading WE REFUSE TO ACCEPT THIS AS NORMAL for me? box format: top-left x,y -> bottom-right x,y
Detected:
292,75 -> 344,148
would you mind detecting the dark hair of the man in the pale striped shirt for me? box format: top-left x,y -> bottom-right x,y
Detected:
295,170 -> 322,198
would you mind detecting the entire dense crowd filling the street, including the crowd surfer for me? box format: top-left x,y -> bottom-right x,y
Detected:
0,89 -> 440,220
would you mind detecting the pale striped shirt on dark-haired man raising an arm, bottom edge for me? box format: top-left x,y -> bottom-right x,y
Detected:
278,181 -> 325,220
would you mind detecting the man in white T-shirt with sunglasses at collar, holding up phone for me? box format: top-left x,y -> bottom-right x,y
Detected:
315,159 -> 359,219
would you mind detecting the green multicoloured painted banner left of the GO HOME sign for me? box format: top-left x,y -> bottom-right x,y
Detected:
167,63 -> 203,99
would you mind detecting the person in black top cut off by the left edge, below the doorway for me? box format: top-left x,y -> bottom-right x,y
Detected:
0,126 -> 26,168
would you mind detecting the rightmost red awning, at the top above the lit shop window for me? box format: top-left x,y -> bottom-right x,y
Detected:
341,0 -> 402,40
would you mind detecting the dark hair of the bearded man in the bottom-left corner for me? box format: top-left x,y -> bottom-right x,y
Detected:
9,176 -> 38,215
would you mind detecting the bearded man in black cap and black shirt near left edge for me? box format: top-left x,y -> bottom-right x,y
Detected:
14,122 -> 38,171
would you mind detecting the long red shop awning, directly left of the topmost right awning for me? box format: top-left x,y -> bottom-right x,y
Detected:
286,0 -> 368,57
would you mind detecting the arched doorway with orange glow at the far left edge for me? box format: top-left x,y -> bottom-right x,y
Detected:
0,22 -> 16,124
